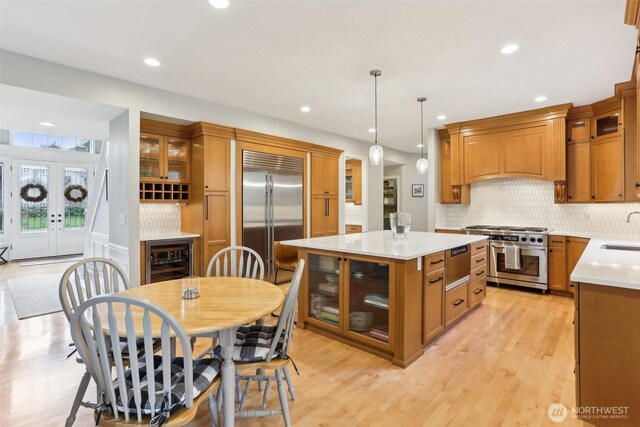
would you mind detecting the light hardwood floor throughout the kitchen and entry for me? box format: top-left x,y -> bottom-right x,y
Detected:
0,264 -> 583,427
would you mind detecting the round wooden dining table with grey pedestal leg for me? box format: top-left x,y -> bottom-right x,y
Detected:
109,277 -> 284,427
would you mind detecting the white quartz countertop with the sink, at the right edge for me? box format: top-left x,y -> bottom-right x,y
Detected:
571,239 -> 640,290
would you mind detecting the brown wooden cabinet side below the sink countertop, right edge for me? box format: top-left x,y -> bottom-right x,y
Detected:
574,283 -> 640,426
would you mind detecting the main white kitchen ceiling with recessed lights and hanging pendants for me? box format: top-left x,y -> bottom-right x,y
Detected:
0,0 -> 636,152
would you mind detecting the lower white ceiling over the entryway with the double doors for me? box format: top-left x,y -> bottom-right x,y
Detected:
0,85 -> 124,140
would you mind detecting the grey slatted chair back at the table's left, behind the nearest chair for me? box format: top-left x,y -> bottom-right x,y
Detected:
58,257 -> 129,321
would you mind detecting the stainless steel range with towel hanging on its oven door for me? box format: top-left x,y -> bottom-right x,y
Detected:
463,225 -> 549,293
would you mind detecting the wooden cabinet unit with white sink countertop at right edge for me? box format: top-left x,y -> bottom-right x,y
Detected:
571,239 -> 640,426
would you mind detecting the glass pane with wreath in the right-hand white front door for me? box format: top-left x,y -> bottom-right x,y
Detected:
64,167 -> 89,230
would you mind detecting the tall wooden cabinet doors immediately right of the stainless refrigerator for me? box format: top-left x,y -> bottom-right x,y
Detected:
311,153 -> 339,237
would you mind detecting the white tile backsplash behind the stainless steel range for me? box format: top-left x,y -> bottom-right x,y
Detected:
436,178 -> 640,240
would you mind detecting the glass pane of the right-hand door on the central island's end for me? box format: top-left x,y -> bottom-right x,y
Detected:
349,260 -> 389,342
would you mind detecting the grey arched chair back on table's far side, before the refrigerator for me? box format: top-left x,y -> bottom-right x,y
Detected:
207,246 -> 264,280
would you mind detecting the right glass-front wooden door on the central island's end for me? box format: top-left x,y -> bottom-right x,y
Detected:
345,258 -> 393,349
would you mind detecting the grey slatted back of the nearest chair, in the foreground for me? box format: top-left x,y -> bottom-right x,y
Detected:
71,294 -> 193,422
